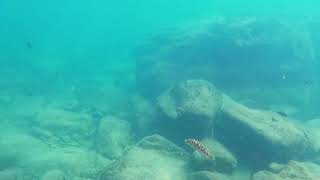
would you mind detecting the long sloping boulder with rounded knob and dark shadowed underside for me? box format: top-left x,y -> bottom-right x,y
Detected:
158,80 -> 318,167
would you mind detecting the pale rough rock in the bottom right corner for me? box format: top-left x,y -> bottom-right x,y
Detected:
252,161 -> 320,180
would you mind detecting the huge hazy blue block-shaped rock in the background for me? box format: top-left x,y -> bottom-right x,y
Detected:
135,17 -> 315,97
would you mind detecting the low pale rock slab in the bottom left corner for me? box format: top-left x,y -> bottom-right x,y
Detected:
0,133 -> 110,180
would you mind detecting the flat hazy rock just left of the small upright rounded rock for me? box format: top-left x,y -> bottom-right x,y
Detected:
31,107 -> 95,146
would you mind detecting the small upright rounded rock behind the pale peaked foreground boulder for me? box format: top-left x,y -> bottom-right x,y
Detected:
97,116 -> 133,158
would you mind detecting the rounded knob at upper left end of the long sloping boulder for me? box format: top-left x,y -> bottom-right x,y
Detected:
158,79 -> 222,119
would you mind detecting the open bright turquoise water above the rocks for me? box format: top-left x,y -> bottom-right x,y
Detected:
0,0 -> 320,63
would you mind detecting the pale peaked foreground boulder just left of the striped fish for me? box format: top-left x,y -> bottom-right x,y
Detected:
99,135 -> 188,180
